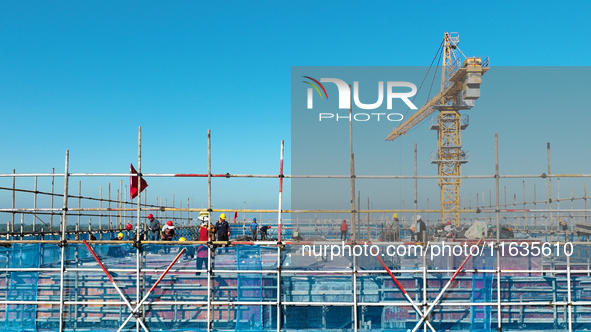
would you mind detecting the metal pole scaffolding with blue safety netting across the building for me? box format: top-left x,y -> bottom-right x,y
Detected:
0,130 -> 591,332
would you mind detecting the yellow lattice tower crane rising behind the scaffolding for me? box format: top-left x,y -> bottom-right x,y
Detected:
386,32 -> 489,225
